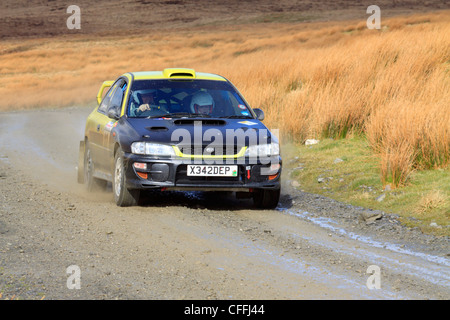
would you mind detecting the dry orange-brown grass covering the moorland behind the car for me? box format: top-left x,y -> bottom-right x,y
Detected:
0,11 -> 450,185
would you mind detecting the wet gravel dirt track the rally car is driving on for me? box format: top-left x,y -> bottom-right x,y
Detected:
0,108 -> 450,299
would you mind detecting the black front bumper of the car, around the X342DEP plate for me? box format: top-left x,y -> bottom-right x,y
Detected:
124,153 -> 281,192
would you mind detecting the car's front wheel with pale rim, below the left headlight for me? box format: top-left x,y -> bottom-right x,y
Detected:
112,148 -> 140,207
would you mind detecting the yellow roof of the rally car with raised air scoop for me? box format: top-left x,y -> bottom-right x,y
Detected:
126,68 -> 227,81
